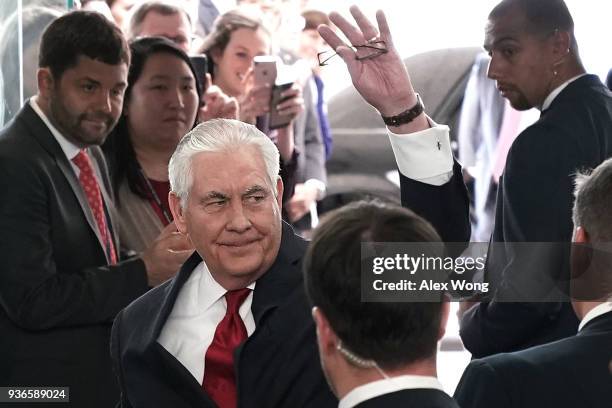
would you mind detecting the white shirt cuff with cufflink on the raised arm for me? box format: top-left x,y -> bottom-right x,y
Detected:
387,117 -> 453,186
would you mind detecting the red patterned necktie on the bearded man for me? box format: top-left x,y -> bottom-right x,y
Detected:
72,150 -> 117,265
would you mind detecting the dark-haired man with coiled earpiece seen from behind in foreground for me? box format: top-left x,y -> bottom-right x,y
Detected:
304,202 -> 458,408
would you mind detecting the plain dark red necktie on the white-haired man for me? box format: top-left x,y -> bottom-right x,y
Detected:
202,288 -> 251,408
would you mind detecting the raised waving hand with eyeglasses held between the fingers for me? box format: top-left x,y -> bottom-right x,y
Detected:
319,6 -> 429,131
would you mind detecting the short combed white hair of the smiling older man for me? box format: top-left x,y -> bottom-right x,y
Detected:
168,119 -> 280,208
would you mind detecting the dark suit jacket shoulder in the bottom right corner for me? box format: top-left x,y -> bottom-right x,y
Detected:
455,312 -> 612,408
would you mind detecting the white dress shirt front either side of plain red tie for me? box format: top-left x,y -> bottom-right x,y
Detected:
157,262 -> 255,384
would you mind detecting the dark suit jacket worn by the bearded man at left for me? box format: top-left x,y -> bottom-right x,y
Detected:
0,104 -> 147,407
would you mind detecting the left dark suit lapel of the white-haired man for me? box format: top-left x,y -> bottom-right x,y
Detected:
135,252 -> 215,407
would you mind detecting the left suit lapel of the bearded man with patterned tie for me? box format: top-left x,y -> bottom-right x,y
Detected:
17,103 -> 109,262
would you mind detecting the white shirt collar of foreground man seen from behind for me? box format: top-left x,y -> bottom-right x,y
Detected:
338,375 -> 444,408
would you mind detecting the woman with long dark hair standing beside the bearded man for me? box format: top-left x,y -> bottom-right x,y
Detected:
103,37 -> 201,252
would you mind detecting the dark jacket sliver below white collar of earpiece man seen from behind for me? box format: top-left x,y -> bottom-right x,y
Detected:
355,388 -> 459,408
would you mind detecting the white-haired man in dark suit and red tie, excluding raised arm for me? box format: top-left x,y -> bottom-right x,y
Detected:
111,119 -> 337,408
